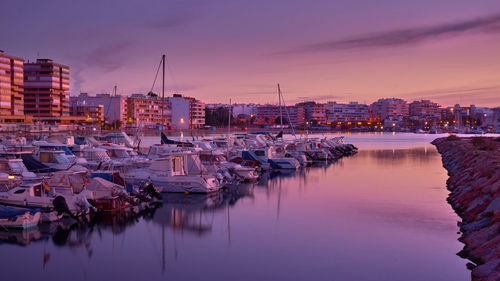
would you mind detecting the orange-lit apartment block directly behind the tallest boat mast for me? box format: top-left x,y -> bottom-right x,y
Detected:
127,94 -> 172,127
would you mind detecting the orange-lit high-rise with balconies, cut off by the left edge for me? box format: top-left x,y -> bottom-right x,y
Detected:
0,50 -> 25,123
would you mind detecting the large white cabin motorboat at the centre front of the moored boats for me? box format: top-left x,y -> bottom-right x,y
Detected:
123,154 -> 221,193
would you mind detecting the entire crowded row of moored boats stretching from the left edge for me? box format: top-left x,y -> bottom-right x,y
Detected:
0,130 -> 357,229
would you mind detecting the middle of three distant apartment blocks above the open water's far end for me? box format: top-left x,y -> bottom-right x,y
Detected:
370,98 -> 409,120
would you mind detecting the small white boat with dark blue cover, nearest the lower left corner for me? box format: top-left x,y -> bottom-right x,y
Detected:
0,205 -> 42,229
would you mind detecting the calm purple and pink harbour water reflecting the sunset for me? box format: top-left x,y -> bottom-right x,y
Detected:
0,134 -> 470,280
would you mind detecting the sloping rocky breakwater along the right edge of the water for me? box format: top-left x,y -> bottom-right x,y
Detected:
432,135 -> 500,280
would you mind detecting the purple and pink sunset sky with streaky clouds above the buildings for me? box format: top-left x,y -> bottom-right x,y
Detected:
0,0 -> 500,107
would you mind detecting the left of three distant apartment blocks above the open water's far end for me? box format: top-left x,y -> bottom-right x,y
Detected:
325,101 -> 370,122
